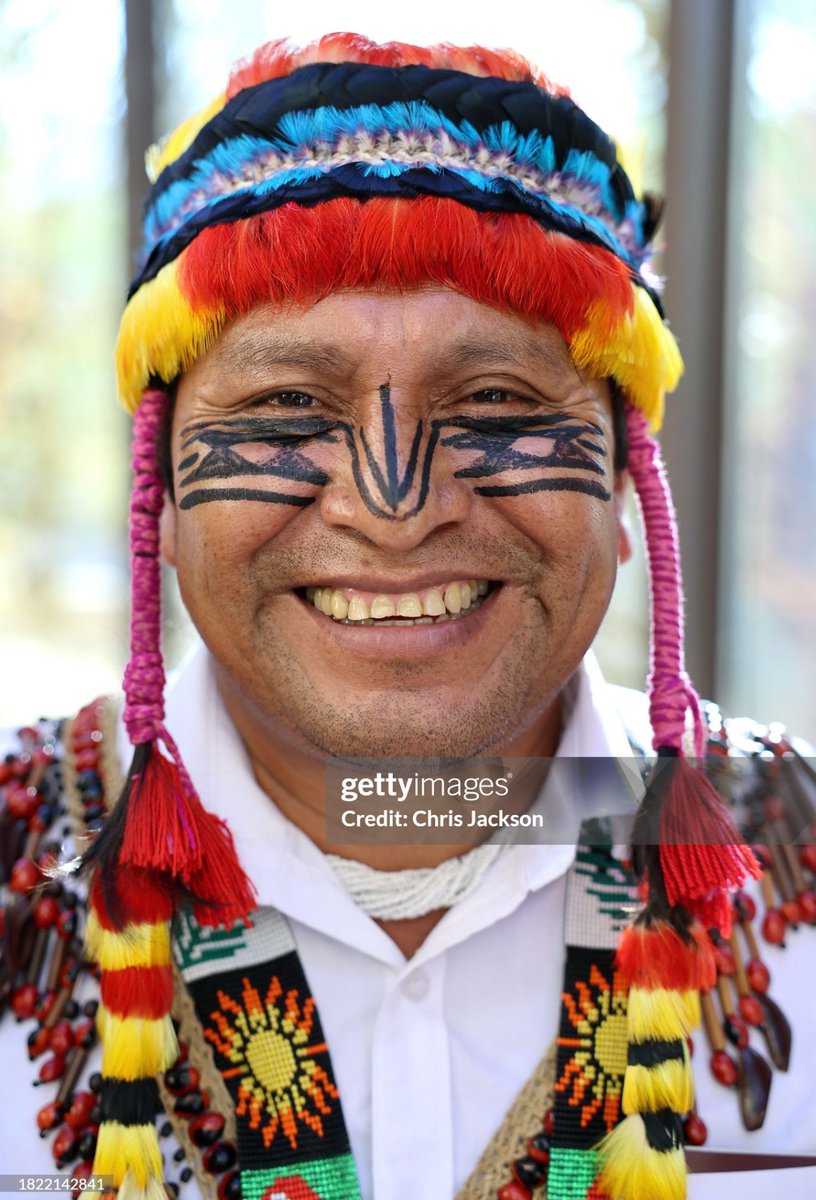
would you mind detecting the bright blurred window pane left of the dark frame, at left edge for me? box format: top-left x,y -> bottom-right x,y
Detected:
0,0 -> 127,722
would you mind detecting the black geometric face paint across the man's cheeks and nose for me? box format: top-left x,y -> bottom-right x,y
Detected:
179,384 -> 612,521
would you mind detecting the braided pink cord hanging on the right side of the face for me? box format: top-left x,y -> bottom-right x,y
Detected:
626,404 -> 706,756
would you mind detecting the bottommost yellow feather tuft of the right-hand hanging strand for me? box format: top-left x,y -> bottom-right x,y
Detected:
599,1116 -> 686,1200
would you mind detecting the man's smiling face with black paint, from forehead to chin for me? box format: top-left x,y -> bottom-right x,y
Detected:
162,288 -> 623,756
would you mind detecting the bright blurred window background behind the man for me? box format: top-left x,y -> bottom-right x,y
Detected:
0,0 -> 816,738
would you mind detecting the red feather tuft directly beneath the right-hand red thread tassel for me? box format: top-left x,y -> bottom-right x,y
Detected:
616,922 -> 716,991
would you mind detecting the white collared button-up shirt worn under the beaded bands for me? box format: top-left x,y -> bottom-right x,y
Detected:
0,649 -> 816,1200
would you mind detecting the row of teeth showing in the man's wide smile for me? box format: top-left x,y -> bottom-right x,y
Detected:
306,580 -> 490,625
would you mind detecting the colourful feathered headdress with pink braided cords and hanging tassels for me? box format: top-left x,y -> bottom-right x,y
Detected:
89,34 -> 754,1200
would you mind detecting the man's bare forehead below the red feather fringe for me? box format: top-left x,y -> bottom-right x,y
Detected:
187,287 -> 576,382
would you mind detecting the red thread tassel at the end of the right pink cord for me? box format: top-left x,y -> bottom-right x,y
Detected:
655,757 -> 760,907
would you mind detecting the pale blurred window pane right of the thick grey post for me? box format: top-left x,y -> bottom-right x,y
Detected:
721,0 -> 816,737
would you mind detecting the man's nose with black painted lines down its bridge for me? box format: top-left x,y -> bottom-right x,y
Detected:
319,384 -> 473,551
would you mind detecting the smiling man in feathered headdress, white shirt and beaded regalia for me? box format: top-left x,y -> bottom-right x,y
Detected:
5,28 -> 815,1200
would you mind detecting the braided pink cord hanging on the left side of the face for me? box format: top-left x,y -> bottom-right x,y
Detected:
125,389 -> 174,745
